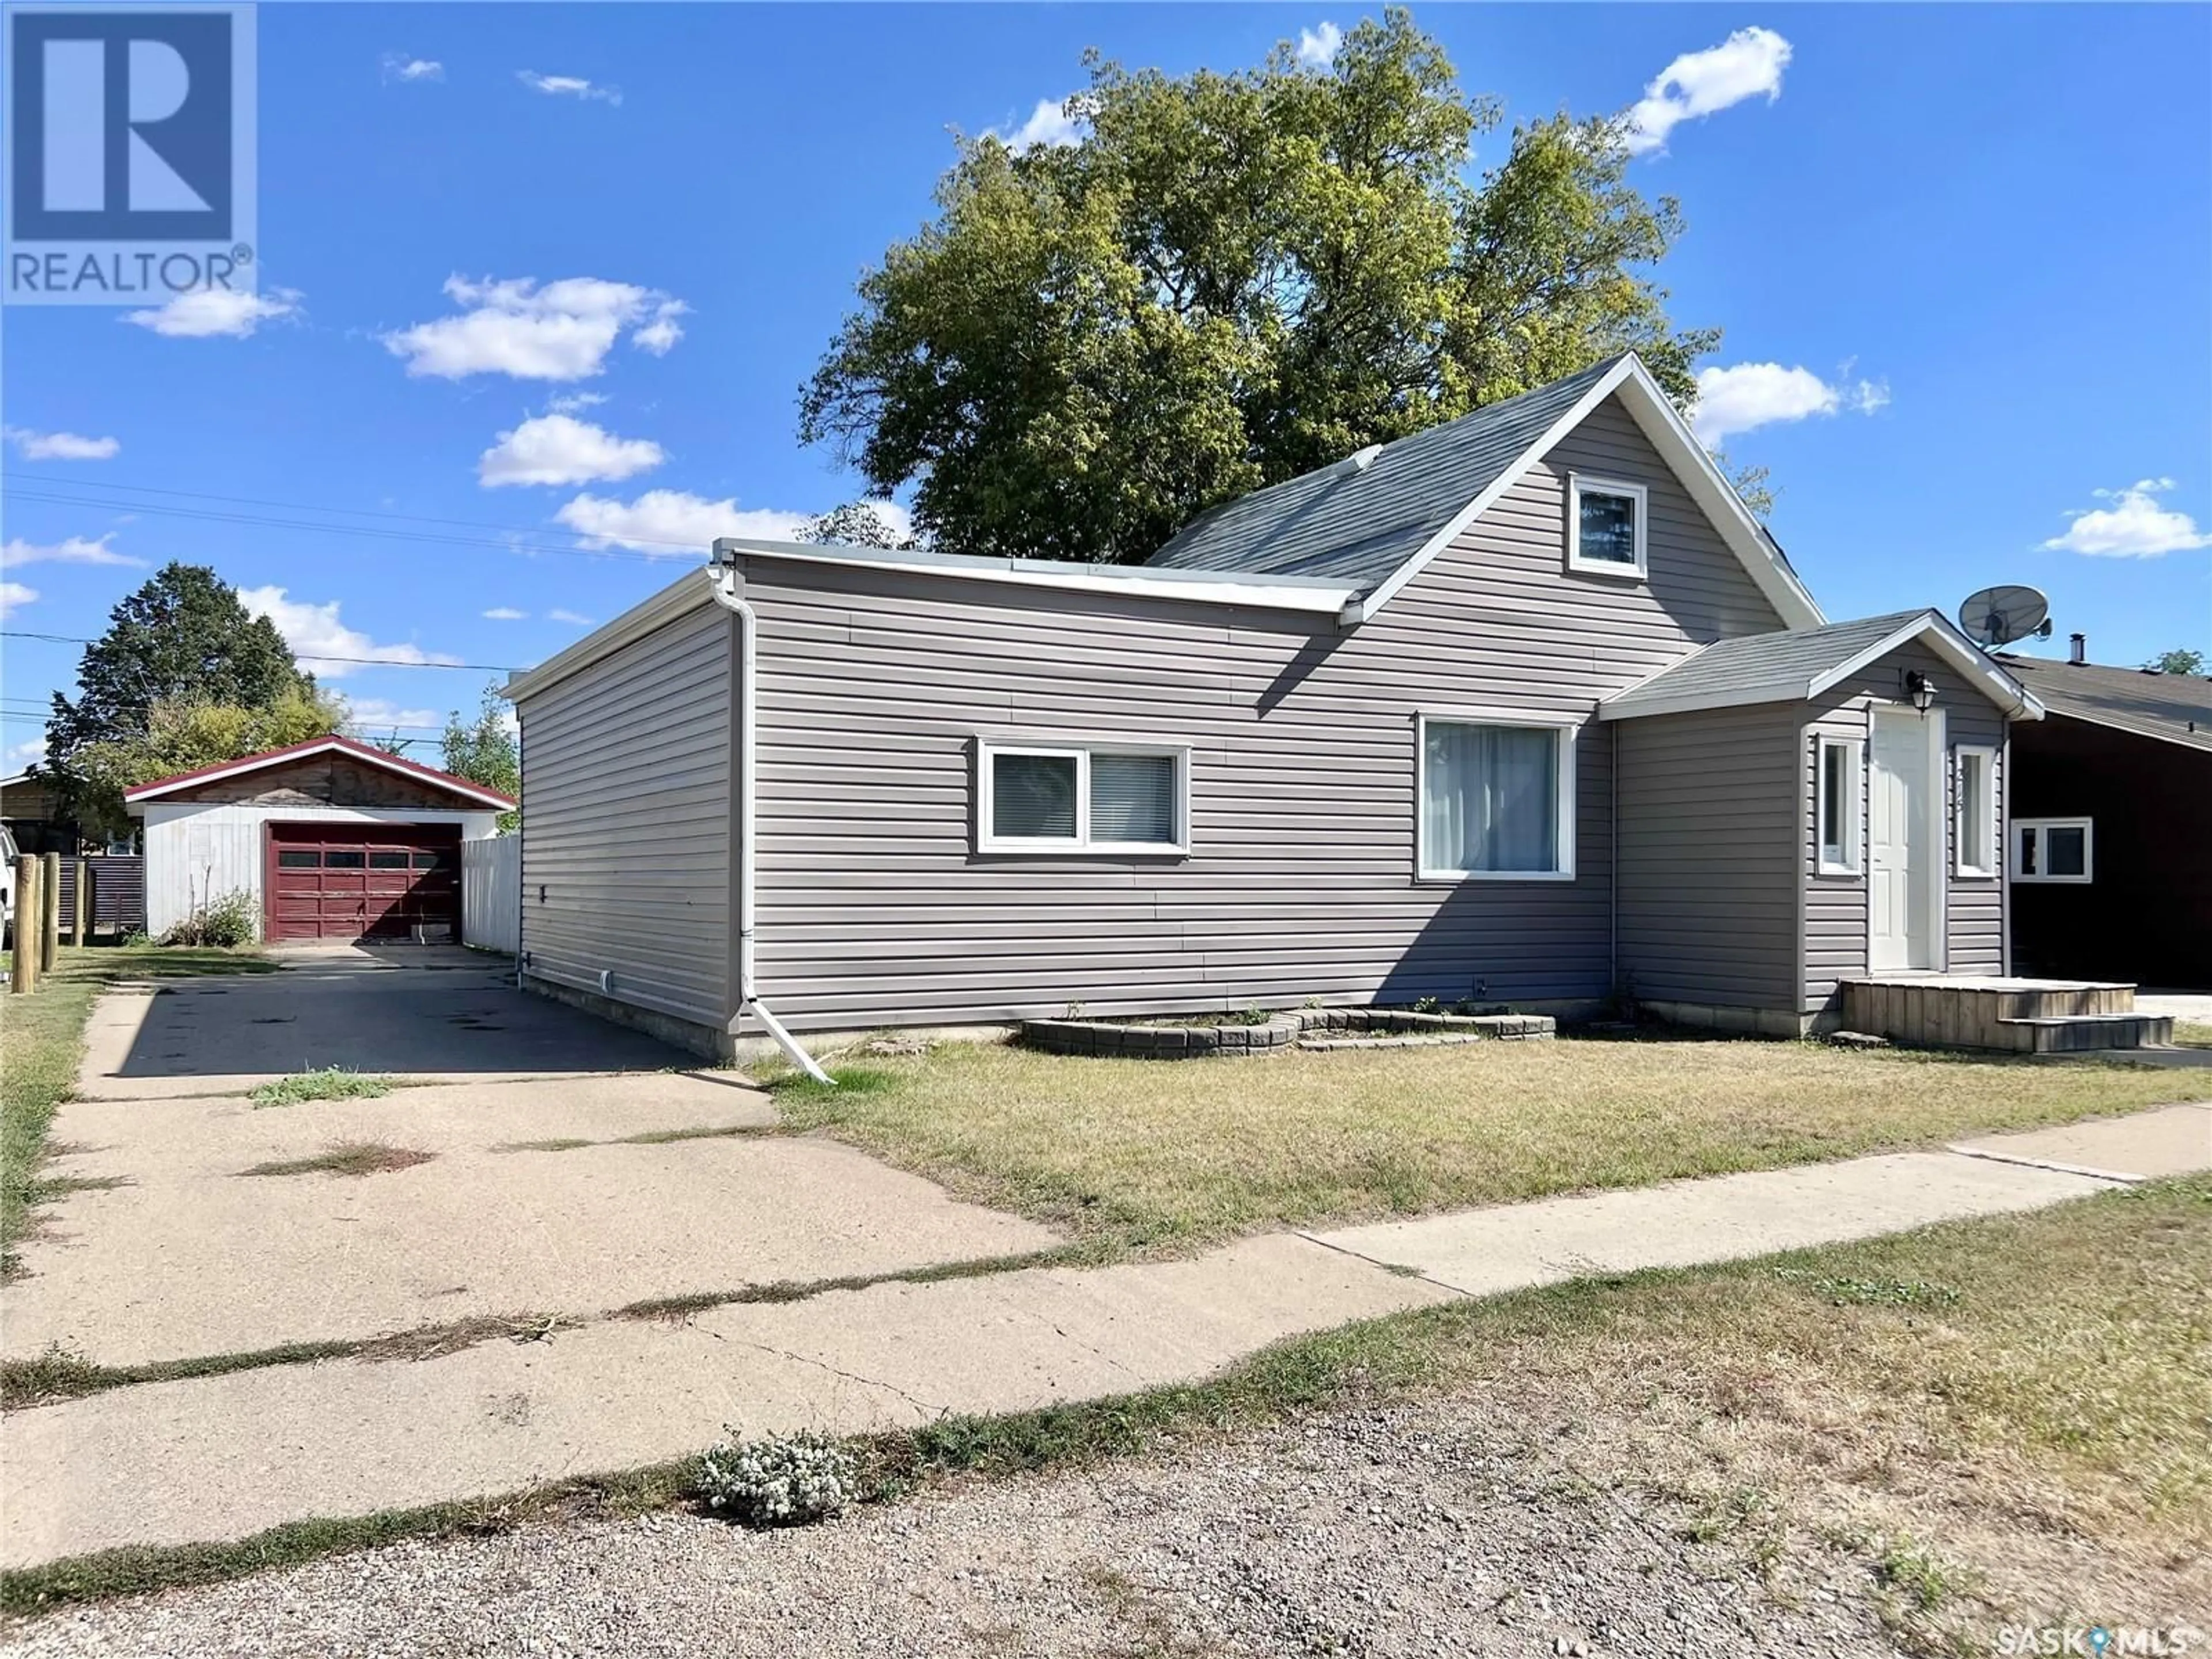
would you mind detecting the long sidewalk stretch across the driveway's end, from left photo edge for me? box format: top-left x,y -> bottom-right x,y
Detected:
0,1237 -> 1449,1566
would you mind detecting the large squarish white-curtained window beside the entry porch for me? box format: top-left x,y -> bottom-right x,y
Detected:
1420,721 -> 1559,872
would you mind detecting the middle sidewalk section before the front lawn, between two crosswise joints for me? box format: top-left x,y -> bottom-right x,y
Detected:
1307,1153 -> 2110,1296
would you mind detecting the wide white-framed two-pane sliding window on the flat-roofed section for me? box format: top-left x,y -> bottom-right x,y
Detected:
975,737 -> 1190,854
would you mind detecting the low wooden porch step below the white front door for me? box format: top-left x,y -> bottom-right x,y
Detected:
1843,974 -> 2172,1055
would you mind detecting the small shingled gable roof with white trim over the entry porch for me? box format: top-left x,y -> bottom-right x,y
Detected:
1597,611 -> 2044,721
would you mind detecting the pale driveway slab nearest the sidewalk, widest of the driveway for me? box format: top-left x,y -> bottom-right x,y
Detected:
0,1141 -> 1059,1365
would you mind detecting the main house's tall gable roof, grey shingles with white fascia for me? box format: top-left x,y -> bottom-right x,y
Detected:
1146,352 -> 1823,628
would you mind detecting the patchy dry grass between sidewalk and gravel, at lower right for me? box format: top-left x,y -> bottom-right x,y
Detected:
1425,1177 -> 2212,1652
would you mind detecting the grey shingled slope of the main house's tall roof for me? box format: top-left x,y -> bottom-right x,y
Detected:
1146,356 -> 1619,588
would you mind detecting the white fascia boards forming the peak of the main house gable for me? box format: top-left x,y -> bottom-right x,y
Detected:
1345,354 -> 1827,628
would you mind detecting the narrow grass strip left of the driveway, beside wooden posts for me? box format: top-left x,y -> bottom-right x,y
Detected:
0,945 -> 279,1274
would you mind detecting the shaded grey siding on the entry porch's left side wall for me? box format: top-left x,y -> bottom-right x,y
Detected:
1612,703 -> 1798,1009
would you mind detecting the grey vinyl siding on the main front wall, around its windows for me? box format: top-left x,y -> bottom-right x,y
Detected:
743,403 -> 1794,1031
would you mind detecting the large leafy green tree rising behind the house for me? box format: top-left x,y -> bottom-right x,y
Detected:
801,11 -> 1717,562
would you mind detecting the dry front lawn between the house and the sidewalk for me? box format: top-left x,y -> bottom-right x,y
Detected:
774,1040 -> 2212,1245
